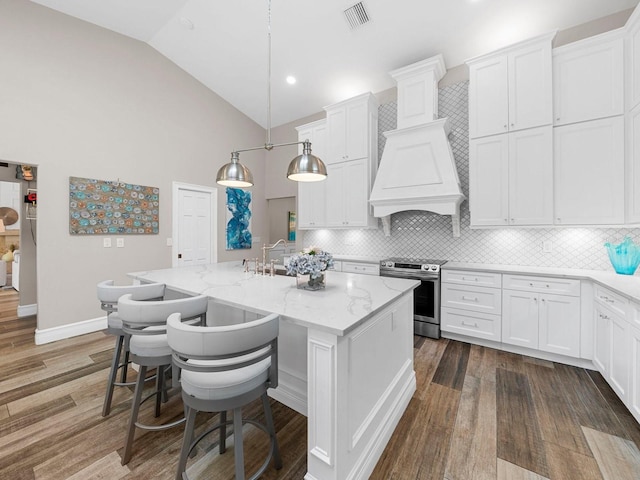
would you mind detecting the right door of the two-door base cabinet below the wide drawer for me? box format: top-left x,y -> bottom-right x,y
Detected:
539,295 -> 580,358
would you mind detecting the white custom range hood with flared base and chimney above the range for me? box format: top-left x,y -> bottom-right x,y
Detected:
369,55 -> 465,237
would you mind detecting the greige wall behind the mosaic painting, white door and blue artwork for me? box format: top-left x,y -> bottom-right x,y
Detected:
0,0 -> 268,329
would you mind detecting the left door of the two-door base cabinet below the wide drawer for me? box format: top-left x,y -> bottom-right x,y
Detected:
502,290 -> 539,349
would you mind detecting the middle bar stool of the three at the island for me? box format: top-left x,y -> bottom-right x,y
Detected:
118,295 -> 209,465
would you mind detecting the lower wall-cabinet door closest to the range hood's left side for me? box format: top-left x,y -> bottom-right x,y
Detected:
342,159 -> 370,227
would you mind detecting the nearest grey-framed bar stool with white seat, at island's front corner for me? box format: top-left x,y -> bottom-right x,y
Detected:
167,314 -> 282,480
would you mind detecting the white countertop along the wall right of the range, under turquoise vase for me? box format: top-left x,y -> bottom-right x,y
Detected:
442,262 -> 640,302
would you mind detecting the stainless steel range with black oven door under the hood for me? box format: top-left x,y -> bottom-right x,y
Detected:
380,258 -> 447,338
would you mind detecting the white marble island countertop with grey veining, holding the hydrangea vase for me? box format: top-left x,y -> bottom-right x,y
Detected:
129,262 -> 420,336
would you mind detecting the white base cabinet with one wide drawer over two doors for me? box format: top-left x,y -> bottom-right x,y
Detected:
502,274 -> 580,357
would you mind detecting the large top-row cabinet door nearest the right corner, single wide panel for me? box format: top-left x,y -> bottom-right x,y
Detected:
553,30 -> 624,125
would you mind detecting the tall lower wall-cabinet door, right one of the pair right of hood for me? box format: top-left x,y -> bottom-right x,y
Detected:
509,125 -> 553,225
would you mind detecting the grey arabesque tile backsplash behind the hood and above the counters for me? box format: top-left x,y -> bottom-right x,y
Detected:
299,82 -> 640,271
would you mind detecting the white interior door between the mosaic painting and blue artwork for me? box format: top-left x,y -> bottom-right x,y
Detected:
172,182 -> 217,267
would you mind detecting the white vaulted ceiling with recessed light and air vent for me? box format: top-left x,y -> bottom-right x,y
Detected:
32,0 -> 639,126
